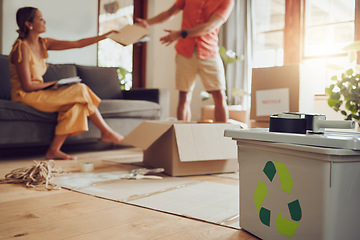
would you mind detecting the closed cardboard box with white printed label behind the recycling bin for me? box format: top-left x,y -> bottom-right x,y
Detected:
250,64 -> 316,121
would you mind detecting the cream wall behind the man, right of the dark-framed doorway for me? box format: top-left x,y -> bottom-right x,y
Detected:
146,0 -> 211,121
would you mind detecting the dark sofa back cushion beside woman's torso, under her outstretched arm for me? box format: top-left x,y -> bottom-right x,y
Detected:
43,64 -> 76,82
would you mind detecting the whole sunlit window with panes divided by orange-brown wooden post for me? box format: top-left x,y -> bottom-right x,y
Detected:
253,0 -> 360,94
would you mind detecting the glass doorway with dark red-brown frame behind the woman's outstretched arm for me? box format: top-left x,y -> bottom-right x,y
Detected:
98,0 -> 147,90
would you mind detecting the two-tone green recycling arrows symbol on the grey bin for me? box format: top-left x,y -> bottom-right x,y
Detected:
254,161 -> 302,237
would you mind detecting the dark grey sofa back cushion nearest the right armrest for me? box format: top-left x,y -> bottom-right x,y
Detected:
76,65 -> 122,99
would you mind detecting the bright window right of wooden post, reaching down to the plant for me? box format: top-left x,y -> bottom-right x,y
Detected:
303,0 -> 355,94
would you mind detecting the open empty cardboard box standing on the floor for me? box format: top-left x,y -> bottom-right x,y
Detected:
124,121 -> 240,176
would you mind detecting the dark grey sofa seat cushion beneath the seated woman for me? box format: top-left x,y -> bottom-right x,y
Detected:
0,100 -> 57,123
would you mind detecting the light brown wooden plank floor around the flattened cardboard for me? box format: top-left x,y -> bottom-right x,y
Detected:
0,148 -> 258,240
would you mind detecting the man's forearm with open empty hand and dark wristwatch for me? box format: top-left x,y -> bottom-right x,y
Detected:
160,14 -> 224,46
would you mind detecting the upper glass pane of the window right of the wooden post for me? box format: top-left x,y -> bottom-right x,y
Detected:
304,0 -> 355,58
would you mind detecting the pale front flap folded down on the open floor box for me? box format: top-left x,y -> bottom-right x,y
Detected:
174,123 -> 240,162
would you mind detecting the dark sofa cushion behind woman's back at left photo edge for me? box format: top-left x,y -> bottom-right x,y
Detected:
0,55 -> 11,100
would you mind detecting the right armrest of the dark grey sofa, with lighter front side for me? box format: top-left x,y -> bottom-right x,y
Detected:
122,88 -> 169,120
